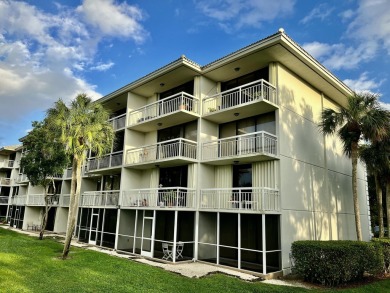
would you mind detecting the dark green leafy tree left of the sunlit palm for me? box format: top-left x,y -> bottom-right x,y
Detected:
20,121 -> 68,240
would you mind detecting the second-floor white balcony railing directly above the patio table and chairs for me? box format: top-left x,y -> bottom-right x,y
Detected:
120,187 -> 196,209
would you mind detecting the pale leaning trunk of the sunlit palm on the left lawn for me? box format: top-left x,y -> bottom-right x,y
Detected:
62,158 -> 81,259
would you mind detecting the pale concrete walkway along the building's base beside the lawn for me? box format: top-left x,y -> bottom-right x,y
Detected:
0,225 -> 307,288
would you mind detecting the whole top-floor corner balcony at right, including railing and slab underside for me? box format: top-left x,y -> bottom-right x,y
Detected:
203,79 -> 278,123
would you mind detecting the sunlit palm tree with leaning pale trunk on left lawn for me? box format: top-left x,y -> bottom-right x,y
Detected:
47,94 -> 114,259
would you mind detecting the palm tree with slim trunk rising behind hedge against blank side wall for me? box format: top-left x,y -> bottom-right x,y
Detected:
319,92 -> 390,241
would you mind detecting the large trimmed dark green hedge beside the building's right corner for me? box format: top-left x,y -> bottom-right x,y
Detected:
291,240 -> 383,286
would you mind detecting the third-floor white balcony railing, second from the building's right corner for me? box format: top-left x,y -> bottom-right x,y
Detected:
126,138 -> 197,164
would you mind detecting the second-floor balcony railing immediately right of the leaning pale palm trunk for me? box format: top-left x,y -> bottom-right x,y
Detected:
80,190 -> 119,207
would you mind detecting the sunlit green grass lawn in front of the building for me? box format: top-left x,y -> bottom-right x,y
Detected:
0,228 -> 390,292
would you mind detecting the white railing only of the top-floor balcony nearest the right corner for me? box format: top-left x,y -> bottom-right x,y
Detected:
203,79 -> 278,114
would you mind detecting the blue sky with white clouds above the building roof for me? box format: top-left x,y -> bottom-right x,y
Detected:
0,0 -> 390,147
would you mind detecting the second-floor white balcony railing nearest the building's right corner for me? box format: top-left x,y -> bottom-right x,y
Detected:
200,187 -> 280,212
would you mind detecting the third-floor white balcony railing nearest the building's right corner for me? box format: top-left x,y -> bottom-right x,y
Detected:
202,131 -> 278,160
